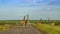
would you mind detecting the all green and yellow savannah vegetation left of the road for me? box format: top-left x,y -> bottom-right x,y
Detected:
0,20 -> 20,31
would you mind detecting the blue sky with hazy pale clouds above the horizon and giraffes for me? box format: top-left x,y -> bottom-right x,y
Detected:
0,0 -> 60,20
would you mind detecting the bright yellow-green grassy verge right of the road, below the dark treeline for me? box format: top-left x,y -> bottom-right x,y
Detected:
33,24 -> 60,34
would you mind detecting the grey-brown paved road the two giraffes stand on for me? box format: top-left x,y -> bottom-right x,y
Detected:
0,25 -> 43,34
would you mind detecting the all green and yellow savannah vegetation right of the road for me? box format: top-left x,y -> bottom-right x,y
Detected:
31,20 -> 60,34
